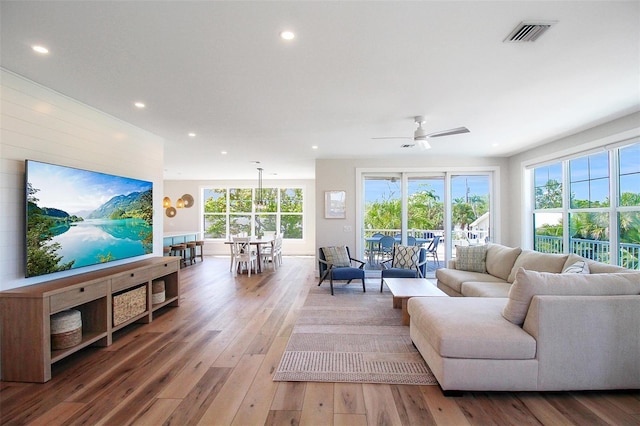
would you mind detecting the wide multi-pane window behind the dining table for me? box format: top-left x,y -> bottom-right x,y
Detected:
202,188 -> 303,239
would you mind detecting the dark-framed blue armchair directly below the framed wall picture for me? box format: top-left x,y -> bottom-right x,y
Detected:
318,246 -> 367,296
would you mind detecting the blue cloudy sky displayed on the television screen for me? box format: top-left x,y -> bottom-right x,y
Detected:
27,161 -> 152,214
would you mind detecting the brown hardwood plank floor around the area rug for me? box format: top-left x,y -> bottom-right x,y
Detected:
0,257 -> 640,426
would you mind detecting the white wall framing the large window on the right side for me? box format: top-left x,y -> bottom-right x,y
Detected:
505,112 -> 640,249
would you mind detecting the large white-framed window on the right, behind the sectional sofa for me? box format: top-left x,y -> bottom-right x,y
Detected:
533,143 -> 640,269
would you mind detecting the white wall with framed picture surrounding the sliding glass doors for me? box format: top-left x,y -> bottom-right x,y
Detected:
316,153 -> 510,256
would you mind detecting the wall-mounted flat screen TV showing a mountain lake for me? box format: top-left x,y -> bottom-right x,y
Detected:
25,160 -> 153,277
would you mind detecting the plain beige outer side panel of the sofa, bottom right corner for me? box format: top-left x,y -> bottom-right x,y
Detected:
523,295 -> 640,390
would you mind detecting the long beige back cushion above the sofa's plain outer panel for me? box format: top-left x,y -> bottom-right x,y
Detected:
502,268 -> 640,325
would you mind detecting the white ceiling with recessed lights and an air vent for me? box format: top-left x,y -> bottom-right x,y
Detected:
0,0 -> 640,179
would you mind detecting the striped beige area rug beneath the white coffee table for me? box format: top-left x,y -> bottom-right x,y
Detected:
273,279 -> 437,385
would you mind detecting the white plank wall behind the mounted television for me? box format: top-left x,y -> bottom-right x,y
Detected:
0,69 -> 164,290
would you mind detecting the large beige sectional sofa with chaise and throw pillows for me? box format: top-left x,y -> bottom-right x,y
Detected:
408,244 -> 640,391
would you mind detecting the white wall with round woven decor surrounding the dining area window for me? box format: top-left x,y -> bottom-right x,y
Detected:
163,178 -> 316,255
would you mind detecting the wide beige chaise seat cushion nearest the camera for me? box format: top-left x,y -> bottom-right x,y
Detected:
408,297 -> 536,359
